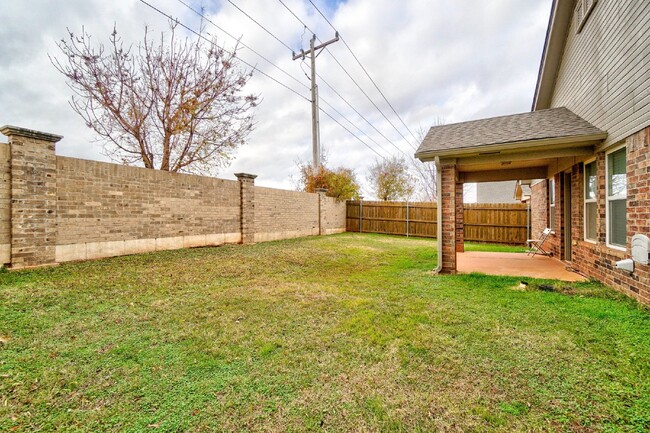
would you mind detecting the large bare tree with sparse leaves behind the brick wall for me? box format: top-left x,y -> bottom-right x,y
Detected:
50,22 -> 257,174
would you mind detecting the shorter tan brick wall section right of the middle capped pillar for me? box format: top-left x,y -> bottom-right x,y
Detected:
255,186 -> 322,242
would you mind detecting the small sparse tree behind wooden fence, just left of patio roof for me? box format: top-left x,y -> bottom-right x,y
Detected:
368,156 -> 415,201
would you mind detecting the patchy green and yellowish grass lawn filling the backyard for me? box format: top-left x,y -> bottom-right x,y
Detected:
0,233 -> 650,432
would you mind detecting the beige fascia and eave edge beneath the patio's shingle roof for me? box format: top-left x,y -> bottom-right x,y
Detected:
415,132 -> 607,162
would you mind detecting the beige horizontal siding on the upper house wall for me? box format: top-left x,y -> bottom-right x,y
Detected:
551,0 -> 650,146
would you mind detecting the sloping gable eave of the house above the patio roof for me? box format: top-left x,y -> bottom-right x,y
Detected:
532,0 -> 574,111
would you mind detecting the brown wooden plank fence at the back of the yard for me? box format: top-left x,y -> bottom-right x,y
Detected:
346,201 -> 528,244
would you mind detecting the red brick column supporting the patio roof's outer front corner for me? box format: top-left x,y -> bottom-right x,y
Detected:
438,165 -> 463,274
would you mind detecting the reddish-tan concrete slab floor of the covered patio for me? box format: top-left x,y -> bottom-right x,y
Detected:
456,251 -> 587,282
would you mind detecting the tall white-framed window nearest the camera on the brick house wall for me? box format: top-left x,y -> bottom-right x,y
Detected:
607,147 -> 627,248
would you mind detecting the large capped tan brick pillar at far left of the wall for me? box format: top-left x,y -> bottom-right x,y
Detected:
0,126 -> 63,268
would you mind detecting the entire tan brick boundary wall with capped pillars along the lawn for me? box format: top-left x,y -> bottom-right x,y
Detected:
0,126 -> 345,268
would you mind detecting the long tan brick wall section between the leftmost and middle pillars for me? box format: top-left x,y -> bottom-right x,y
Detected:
56,157 -> 241,262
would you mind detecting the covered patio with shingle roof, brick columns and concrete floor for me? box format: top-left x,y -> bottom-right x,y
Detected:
415,107 -> 607,281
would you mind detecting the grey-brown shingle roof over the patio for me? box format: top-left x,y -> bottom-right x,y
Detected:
416,107 -> 605,155
